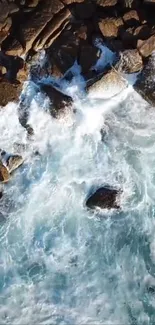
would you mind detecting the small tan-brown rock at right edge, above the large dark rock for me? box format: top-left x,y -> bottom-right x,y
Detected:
137,35 -> 155,58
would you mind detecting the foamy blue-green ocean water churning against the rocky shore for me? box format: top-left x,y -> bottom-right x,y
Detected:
0,58 -> 155,325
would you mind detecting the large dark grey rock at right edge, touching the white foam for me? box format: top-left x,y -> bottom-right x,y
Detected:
134,54 -> 155,106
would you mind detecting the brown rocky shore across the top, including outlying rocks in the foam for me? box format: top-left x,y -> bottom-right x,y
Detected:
0,0 -> 155,208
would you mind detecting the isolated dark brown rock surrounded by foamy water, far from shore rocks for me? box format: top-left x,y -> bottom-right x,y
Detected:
86,187 -> 120,209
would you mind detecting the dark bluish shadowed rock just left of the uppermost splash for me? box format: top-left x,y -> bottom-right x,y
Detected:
78,43 -> 99,74
